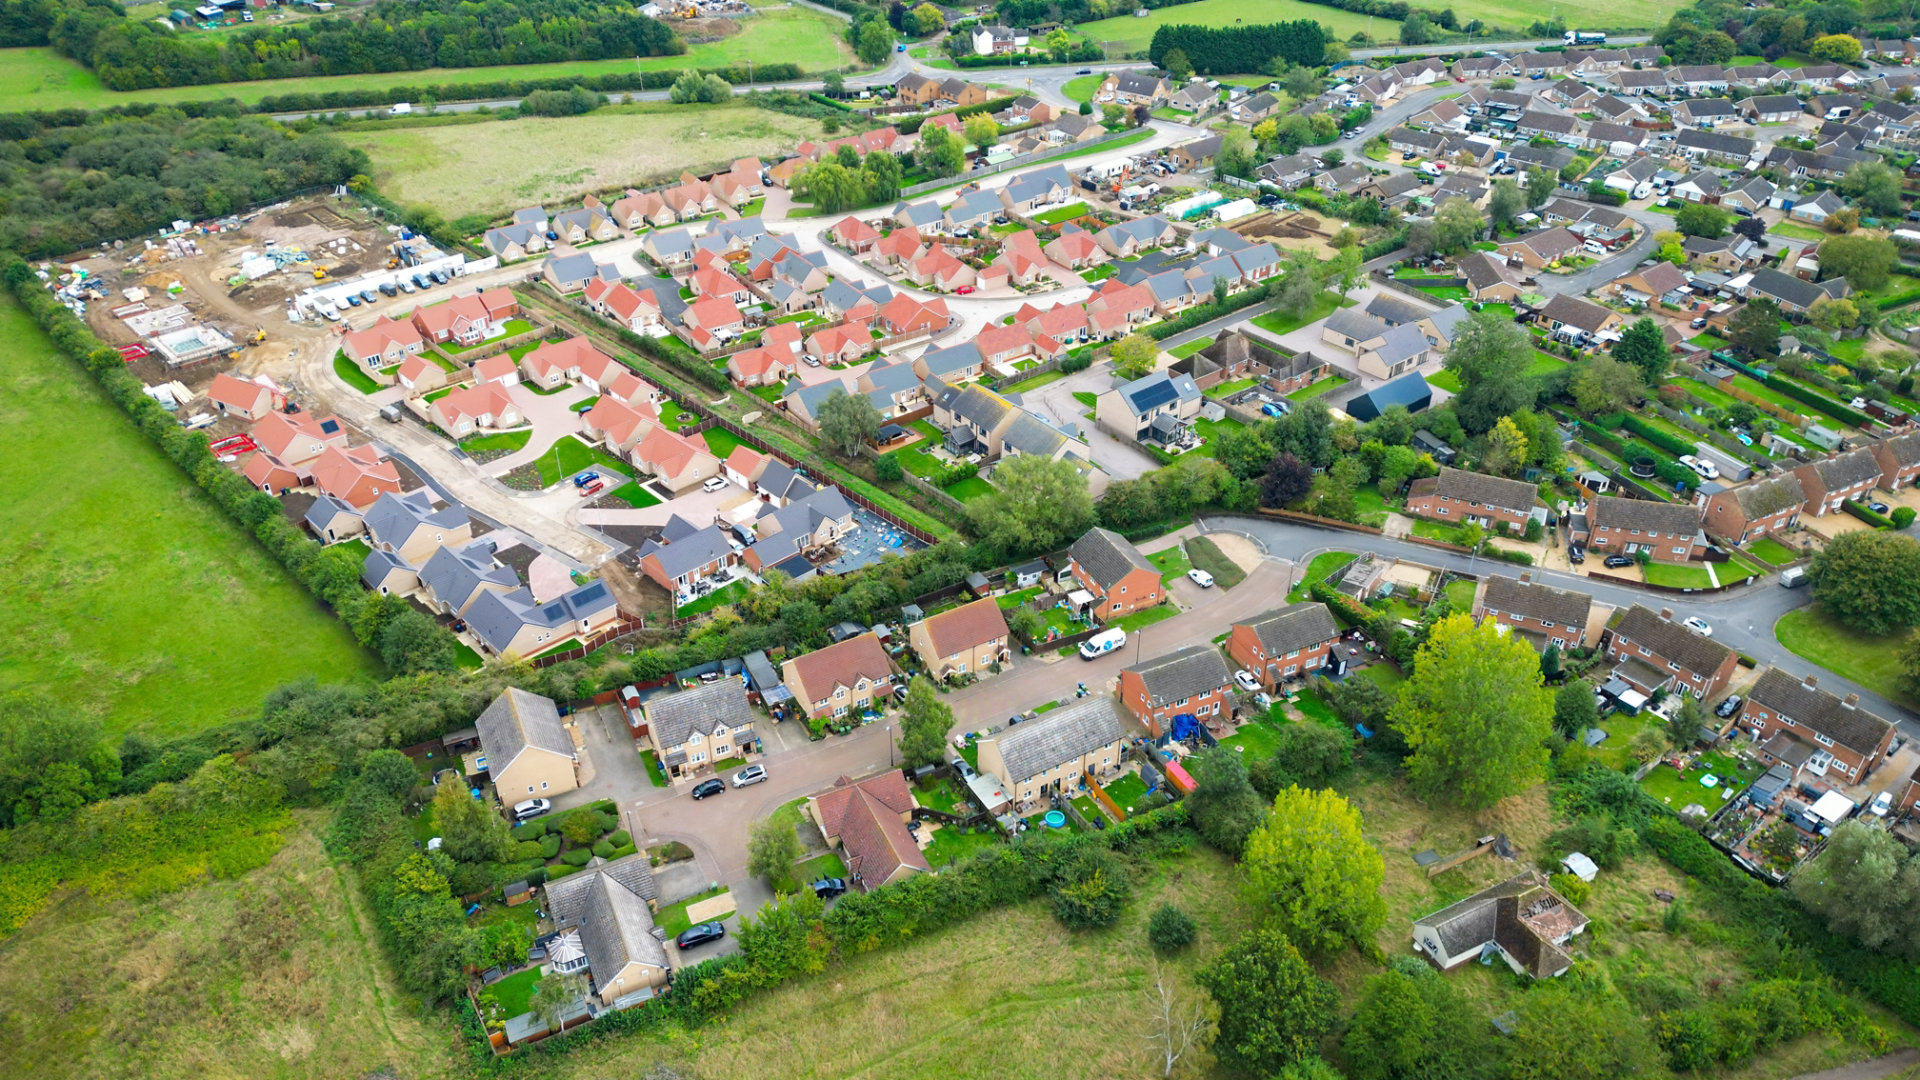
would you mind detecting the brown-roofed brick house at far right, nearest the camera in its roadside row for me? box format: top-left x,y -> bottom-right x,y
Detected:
1738,667 -> 1893,784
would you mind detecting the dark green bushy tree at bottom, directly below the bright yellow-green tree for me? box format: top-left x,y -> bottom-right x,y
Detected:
1194,928 -> 1340,1076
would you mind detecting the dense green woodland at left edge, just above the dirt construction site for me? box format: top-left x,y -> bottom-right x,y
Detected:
0,110 -> 367,257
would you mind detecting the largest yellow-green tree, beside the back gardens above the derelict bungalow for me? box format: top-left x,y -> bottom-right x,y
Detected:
1394,615 -> 1553,809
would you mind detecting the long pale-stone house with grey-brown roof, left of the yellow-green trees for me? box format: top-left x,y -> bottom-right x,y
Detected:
977,694 -> 1127,813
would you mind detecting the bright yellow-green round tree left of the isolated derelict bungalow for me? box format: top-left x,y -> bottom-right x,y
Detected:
1242,788 -> 1386,953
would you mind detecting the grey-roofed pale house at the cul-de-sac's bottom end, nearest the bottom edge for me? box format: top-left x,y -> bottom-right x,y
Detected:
536,855 -> 670,1006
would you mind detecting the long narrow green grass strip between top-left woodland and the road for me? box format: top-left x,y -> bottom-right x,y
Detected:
0,8 -> 852,110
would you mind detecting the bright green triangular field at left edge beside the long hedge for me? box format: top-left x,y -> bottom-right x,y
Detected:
0,300 -> 380,736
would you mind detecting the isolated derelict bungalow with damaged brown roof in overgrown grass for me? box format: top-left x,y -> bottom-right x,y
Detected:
1413,871 -> 1588,978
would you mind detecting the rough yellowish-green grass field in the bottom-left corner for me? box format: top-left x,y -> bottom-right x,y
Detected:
0,811 -> 453,1080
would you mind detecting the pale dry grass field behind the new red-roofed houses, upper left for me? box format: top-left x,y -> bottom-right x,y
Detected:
346,102 -> 820,217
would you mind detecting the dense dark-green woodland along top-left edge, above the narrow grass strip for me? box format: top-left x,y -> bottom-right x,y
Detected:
38,0 -> 687,90
